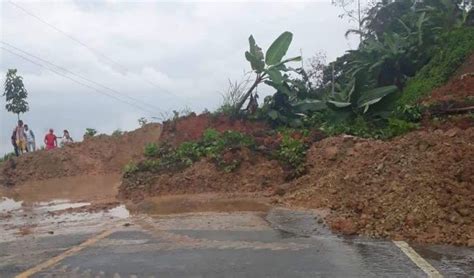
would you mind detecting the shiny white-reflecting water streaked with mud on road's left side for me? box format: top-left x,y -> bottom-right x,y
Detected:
0,197 -> 130,242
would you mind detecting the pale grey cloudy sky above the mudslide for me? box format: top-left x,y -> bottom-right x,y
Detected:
0,0 -> 356,154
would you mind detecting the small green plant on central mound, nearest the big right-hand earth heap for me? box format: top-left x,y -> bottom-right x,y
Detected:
277,133 -> 307,176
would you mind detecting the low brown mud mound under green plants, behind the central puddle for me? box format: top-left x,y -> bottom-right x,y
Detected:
120,150 -> 286,201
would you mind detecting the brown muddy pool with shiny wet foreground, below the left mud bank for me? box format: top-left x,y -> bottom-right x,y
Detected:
0,175 -> 130,242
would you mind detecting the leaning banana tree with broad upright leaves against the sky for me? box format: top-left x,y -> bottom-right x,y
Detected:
235,32 -> 301,111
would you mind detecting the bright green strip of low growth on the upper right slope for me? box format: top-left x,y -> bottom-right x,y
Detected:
398,27 -> 474,106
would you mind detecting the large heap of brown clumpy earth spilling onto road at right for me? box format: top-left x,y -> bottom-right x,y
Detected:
282,125 -> 474,246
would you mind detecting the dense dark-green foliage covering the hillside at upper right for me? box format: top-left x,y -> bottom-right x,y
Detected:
239,0 -> 474,138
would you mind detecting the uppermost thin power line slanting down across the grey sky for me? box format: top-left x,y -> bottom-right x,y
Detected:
8,0 -> 189,104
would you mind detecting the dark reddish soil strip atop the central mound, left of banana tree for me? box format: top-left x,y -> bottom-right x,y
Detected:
161,114 -> 268,145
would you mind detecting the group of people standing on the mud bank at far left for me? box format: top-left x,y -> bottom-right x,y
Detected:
11,120 -> 74,156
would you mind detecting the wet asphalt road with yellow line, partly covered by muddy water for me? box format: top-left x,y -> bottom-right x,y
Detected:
0,195 -> 474,277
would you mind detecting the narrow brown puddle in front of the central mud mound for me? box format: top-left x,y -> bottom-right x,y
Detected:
131,195 -> 270,215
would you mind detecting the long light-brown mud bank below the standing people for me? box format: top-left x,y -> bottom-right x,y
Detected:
0,124 -> 161,186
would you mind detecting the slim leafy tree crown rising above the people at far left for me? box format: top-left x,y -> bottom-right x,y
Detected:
2,69 -> 30,120
